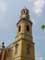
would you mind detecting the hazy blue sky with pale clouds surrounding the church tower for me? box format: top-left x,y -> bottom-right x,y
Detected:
0,0 -> 45,60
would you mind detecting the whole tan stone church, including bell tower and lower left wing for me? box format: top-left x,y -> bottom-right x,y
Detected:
0,8 -> 35,60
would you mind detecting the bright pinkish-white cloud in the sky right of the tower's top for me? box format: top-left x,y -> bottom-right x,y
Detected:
28,0 -> 45,15
